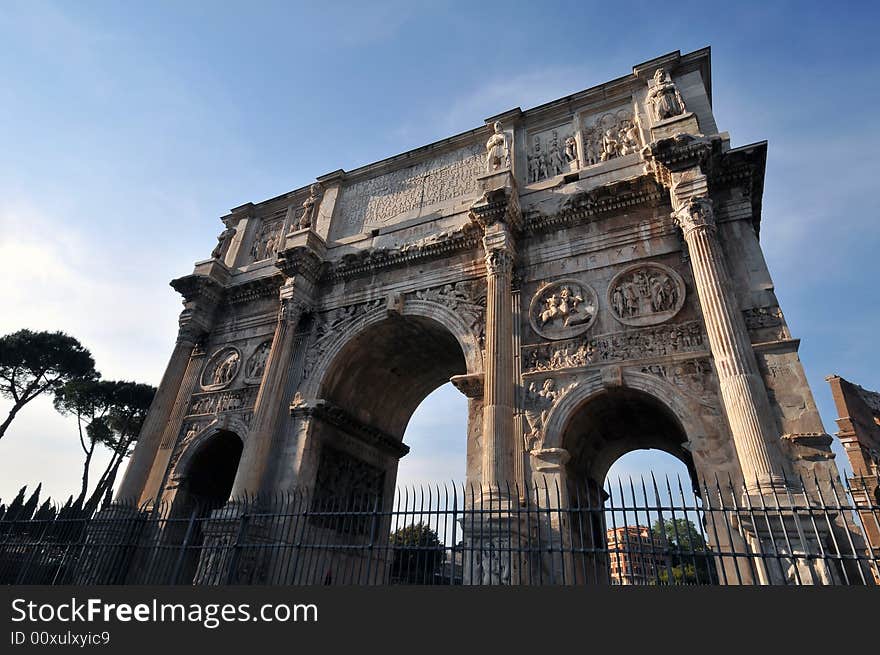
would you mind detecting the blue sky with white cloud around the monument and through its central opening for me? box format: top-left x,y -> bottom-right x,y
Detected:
0,0 -> 880,498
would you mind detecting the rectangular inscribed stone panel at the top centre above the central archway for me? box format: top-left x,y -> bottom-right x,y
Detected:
336,143 -> 486,236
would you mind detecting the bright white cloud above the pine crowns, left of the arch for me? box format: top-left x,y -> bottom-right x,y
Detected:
0,201 -> 179,384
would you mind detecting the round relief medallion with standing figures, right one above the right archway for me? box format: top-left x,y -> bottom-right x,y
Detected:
608,264 -> 684,325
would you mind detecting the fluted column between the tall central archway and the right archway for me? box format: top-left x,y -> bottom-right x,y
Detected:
482,223 -> 515,486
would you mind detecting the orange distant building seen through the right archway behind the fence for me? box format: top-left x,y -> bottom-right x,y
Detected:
606,525 -> 669,585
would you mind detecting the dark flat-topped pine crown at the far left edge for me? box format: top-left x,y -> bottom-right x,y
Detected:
0,330 -> 95,438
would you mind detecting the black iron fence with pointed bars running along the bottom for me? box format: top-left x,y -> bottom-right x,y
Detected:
0,477 -> 880,585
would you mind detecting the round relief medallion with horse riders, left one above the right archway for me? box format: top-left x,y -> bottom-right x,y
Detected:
529,279 -> 599,339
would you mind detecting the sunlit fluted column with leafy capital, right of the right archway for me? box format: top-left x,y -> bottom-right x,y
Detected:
673,196 -> 783,487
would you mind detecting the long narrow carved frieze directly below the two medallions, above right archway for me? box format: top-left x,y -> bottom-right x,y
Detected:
523,321 -> 706,374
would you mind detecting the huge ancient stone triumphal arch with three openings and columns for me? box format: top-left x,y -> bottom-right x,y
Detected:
111,49 -> 836,584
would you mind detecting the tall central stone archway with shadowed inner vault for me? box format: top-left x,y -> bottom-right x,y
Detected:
294,300 -> 482,508
